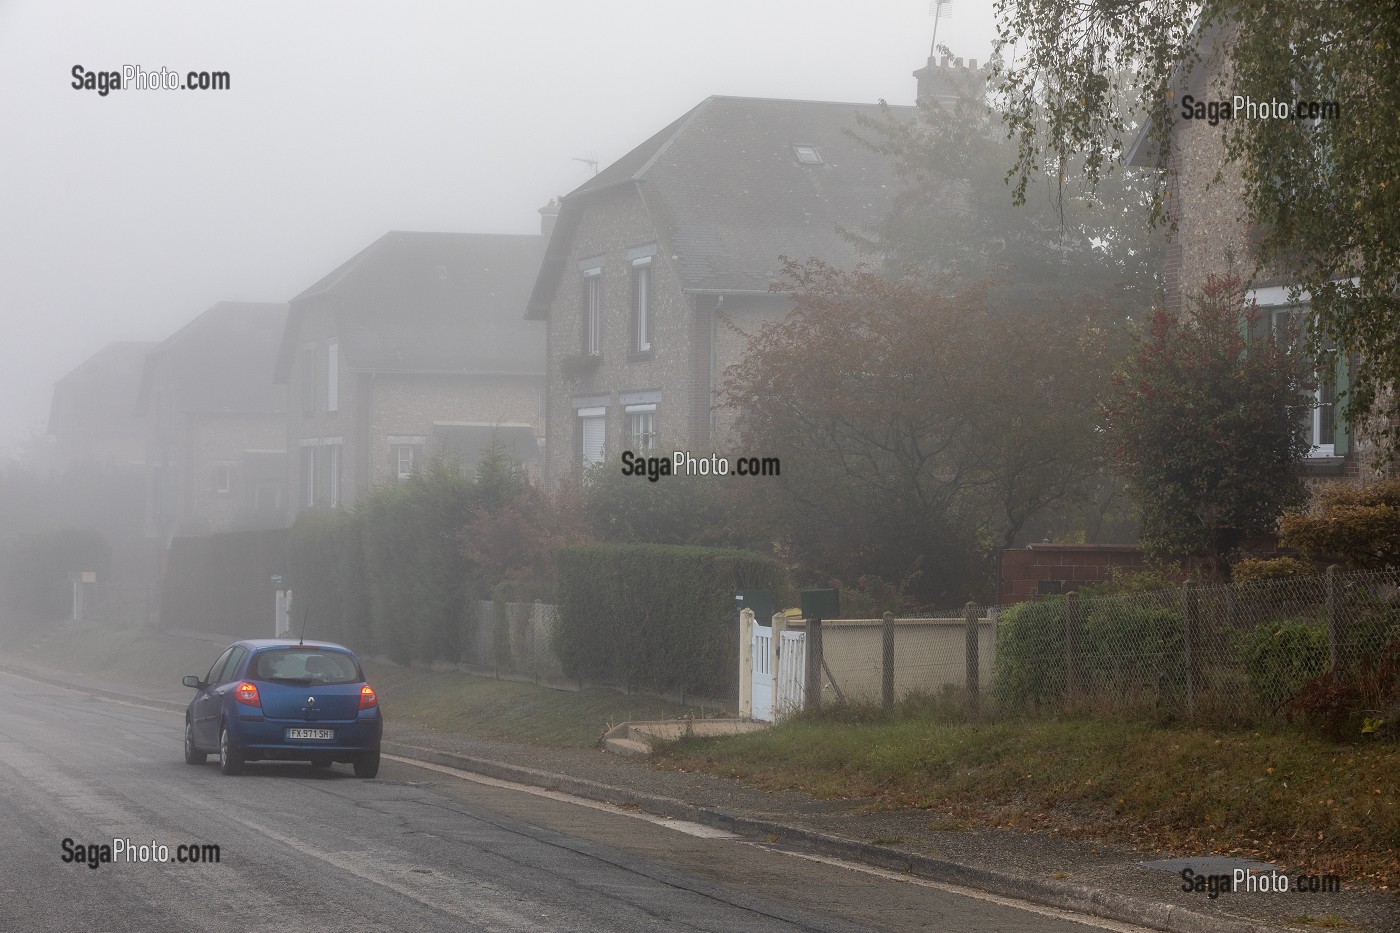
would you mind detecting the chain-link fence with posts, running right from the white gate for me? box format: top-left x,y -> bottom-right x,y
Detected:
823,572 -> 1400,723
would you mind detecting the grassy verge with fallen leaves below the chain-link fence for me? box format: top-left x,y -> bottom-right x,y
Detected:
664,708 -> 1400,890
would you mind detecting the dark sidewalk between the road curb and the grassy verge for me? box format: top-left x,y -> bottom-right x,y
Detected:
0,652 -> 1400,933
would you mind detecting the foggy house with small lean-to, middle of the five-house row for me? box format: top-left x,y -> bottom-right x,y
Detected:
276,231 -> 546,516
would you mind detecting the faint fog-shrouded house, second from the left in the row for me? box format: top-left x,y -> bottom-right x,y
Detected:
137,301 -> 287,548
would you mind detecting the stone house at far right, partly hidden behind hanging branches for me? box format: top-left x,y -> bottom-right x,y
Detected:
1127,21 -> 1378,482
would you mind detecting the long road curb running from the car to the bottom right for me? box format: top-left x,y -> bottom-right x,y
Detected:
381,742 -> 1288,933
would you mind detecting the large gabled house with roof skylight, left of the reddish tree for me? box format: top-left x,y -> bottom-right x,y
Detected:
526,91 -> 918,479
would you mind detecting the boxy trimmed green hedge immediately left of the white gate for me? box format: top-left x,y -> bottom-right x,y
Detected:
554,545 -> 790,698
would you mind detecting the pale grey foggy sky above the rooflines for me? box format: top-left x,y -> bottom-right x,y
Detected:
0,0 -> 994,455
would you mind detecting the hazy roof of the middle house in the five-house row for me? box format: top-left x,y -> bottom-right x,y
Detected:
277,231 -> 545,381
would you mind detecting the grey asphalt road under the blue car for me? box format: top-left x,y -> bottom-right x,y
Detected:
0,674 -> 1126,933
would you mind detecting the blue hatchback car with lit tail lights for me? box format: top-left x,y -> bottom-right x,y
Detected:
183,639 -> 384,778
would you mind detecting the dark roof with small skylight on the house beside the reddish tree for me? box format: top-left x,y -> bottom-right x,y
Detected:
531,97 -> 914,317
